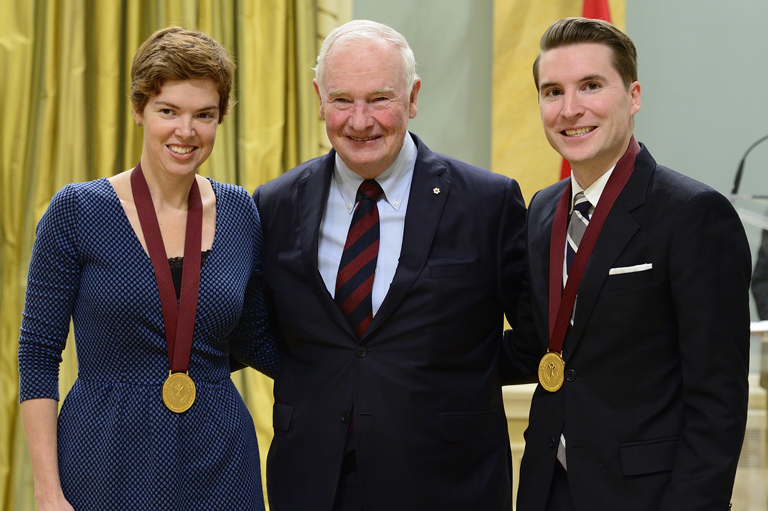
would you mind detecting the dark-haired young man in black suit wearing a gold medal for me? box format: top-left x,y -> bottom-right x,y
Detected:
515,18 -> 750,511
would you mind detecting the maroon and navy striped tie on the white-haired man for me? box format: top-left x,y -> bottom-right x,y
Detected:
334,179 -> 383,338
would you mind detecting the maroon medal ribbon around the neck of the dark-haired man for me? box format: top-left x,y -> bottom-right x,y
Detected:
549,137 -> 640,353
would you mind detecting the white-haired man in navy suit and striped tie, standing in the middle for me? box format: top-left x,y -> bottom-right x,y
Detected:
254,21 -> 525,511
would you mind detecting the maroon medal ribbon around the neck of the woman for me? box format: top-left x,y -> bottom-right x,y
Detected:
131,163 -> 203,373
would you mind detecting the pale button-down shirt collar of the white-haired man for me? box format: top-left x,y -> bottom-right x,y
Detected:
333,132 -> 418,214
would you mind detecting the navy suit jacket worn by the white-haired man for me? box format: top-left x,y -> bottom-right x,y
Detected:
254,135 -> 525,511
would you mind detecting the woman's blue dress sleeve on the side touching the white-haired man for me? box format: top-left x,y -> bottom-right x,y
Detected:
229,197 -> 278,378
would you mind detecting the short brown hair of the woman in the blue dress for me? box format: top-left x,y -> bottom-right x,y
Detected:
130,27 -> 235,123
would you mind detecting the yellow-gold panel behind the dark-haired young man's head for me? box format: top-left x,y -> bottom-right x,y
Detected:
491,0 -> 626,201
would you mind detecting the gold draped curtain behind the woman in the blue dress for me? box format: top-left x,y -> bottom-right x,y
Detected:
0,0 -> 351,510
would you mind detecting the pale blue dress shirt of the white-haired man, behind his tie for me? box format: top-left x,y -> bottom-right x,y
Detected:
317,133 -> 417,315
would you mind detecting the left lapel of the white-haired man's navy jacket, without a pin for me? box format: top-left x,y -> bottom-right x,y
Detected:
297,150 -> 357,339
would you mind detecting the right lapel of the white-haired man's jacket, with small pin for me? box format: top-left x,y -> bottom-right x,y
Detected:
363,134 -> 451,339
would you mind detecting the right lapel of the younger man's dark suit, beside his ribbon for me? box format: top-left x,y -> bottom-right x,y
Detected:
569,147 -> 656,351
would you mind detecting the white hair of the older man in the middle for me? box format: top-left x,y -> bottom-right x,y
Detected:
312,20 -> 418,93
